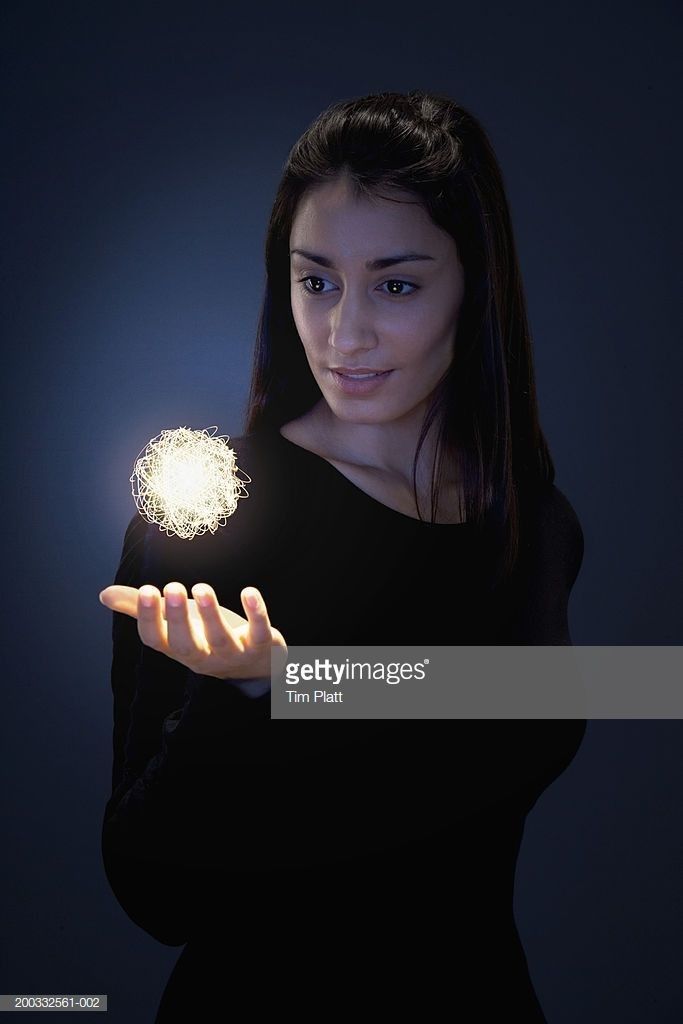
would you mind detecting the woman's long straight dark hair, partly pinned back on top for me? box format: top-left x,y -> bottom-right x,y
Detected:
247,90 -> 555,586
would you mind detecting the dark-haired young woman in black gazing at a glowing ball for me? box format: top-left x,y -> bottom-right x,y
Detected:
100,91 -> 586,1024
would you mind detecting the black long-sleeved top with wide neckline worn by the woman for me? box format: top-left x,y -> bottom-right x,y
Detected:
102,434 -> 586,1022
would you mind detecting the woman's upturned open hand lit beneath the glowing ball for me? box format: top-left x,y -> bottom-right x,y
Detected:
99,583 -> 287,679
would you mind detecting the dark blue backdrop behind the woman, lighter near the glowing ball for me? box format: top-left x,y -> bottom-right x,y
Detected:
0,0 -> 683,1024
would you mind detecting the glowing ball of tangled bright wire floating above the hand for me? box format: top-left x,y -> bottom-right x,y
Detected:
130,427 -> 251,541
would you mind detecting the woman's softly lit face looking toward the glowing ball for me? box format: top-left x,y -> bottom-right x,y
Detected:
290,178 -> 465,424
